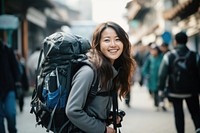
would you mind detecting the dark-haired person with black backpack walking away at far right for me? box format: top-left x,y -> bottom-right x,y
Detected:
158,32 -> 200,133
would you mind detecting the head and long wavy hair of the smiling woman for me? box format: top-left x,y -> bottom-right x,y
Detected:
92,21 -> 136,96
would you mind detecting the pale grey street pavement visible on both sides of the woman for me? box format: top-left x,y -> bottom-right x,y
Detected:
14,84 -> 195,133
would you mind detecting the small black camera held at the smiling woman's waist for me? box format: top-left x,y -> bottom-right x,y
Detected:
106,109 -> 126,127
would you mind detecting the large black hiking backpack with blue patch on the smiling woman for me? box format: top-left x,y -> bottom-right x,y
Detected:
31,32 -> 98,133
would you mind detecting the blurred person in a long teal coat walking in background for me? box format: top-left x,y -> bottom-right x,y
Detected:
142,44 -> 165,110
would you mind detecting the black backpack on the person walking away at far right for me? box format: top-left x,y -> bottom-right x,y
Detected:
169,50 -> 199,94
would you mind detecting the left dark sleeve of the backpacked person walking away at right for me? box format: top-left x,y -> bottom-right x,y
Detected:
157,54 -> 169,91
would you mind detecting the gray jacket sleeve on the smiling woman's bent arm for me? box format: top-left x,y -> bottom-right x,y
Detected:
66,66 -> 105,133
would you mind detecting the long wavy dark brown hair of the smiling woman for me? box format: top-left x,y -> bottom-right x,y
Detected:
90,22 -> 136,97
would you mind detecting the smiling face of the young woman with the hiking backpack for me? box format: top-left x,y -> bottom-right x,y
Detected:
100,27 -> 123,64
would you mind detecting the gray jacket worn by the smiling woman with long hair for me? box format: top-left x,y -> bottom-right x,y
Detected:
66,66 -> 117,133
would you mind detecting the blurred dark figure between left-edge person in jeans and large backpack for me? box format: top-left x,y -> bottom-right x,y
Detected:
16,52 -> 29,112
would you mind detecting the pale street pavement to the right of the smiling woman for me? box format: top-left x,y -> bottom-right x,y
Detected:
119,84 -> 195,133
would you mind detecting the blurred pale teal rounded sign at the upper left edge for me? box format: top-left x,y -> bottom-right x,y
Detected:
0,14 -> 19,30
